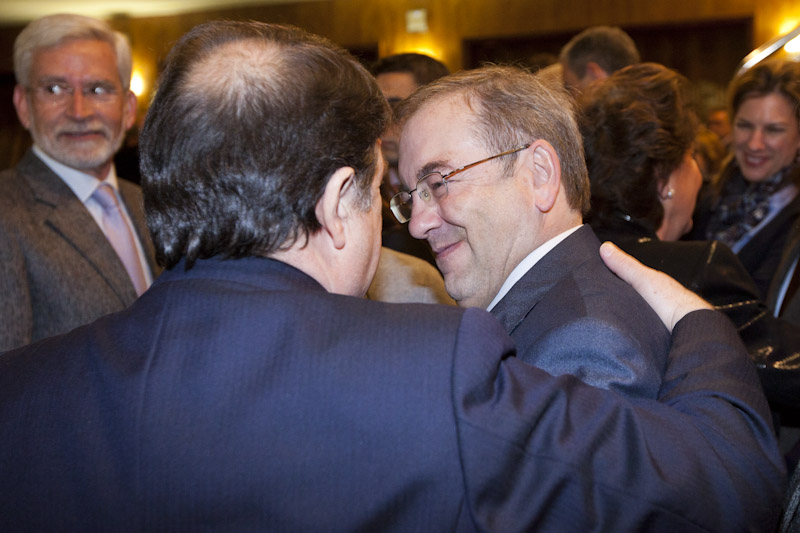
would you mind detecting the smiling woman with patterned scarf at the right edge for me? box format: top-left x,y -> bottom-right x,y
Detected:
692,61 -> 800,297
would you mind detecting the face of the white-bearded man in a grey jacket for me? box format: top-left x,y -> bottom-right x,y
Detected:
14,39 -> 136,179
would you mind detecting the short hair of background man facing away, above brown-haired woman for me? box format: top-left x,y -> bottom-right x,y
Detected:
559,26 -> 641,91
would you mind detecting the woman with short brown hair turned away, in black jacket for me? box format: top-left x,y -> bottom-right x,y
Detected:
579,63 -> 800,426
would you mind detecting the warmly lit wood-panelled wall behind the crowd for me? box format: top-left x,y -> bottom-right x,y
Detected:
0,0 -> 800,133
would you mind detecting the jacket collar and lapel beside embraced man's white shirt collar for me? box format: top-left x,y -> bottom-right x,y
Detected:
491,225 -> 599,335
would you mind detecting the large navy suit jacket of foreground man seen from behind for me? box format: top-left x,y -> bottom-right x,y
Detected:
0,258 -> 785,532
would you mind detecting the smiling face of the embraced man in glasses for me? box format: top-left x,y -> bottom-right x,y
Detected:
400,97 -> 538,307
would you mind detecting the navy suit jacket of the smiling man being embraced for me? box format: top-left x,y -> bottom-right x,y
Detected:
492,225 -> 670,398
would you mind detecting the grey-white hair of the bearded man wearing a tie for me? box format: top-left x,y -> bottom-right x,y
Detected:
14,14 -> 131,91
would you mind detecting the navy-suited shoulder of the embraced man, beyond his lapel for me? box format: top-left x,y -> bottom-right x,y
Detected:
512,237 -> 670,398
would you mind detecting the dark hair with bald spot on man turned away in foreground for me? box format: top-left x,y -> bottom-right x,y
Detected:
140,21 -> 390,268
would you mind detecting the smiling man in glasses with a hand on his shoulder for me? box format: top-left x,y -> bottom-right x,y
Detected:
391,67 -> 669,398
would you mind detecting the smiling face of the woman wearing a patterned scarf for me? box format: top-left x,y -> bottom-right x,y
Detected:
733,93 -> 800,182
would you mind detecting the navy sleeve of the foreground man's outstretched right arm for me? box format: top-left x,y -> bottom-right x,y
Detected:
453,311 -> 785,531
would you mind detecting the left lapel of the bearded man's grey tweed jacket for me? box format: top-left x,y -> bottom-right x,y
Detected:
18,151 -> 136,302
